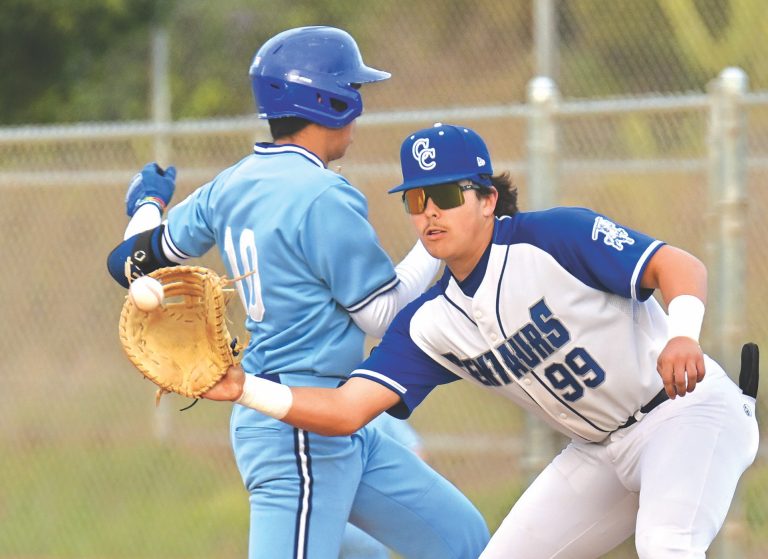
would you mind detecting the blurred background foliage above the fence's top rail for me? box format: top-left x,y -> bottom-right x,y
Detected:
0,0 -> 768,124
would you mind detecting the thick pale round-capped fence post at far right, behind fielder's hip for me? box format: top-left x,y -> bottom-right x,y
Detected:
708,67 -> 748,559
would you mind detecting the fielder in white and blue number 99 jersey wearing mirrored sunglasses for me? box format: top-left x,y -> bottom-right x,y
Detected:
206,125 -> 758,559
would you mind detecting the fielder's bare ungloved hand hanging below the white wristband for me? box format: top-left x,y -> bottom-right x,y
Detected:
656,336 -> 705,400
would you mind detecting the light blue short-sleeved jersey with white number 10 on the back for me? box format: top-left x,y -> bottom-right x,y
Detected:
163,144 -> 397,384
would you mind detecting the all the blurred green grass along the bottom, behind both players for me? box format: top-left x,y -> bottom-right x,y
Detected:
0,430 -> 768,559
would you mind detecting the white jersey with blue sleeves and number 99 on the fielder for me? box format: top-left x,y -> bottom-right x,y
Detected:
353,208 -> 667,442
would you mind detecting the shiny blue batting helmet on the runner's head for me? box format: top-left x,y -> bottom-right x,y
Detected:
249,26 -> 391,128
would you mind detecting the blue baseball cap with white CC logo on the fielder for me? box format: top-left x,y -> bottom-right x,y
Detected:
389,123 -> 493,194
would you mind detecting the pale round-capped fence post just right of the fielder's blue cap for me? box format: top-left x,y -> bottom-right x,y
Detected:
523,76 -> 562,478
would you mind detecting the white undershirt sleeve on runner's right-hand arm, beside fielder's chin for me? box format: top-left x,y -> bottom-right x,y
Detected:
350,241 -> 440,338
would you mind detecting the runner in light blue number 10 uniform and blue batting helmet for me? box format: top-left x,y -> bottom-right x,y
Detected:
108,27 -> 489,559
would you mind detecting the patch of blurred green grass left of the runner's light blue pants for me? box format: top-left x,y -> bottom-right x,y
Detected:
0,444 -> 248,559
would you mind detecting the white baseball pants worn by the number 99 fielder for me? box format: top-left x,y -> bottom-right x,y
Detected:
480,366 -> 758,559
